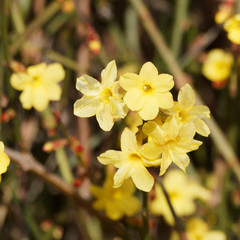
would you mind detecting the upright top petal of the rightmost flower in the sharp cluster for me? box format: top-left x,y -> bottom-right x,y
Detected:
178,84 -> 195,108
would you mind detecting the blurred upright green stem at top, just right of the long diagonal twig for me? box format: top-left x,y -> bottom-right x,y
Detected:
171,0 -> 189,57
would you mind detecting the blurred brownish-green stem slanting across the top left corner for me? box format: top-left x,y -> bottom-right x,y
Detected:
10,1 -> 61,55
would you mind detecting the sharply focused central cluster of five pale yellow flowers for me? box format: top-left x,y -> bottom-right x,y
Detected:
74,61 -> 210,192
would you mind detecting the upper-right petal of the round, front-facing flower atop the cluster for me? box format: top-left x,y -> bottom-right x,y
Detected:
151,73 -> 174,93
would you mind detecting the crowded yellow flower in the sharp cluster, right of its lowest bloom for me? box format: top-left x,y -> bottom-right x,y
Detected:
142,116 -> 202,175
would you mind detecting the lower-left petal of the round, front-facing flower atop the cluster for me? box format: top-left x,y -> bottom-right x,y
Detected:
123,89 -> 145,111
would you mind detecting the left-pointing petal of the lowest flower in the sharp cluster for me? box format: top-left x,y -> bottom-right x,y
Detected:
97,150 -> 122,167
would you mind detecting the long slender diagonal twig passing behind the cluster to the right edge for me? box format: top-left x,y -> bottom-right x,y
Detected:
129,0 -> 240,182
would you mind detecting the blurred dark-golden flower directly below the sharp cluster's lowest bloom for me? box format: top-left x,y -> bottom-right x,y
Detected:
90,174 -> 140,220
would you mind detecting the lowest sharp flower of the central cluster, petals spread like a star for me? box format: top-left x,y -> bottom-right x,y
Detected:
98,128 -> 160,192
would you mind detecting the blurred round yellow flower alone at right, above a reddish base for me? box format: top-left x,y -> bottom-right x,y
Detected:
202,48 -> 233,82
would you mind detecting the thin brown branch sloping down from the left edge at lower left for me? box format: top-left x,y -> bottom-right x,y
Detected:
5,147 -> 127,239
